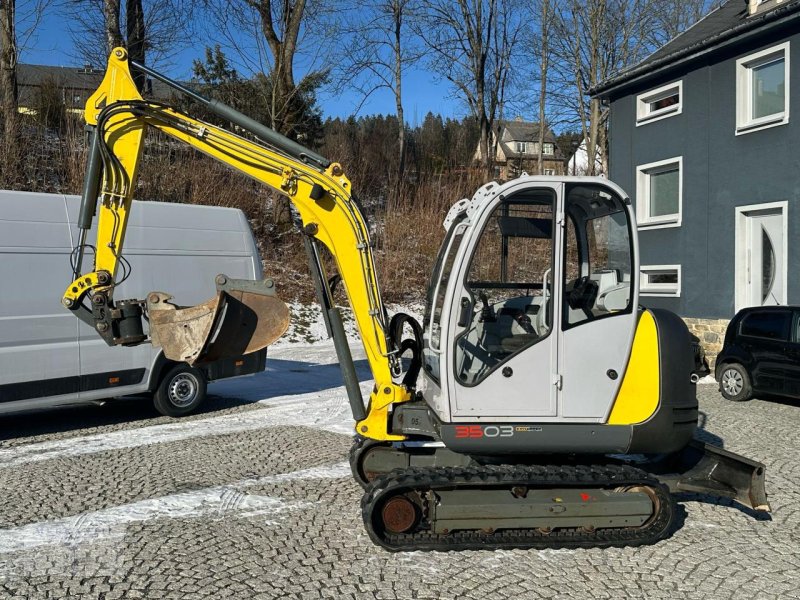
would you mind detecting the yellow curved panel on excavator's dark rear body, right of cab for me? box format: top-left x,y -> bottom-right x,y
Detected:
608,311 -> 661,425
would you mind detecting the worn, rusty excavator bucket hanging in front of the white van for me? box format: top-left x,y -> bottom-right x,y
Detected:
147,275 -> 289,365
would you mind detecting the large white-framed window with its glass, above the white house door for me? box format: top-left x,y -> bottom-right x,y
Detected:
736,42 -> 789,135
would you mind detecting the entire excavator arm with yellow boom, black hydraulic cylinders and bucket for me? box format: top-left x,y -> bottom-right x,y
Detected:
62,48 -> 411,440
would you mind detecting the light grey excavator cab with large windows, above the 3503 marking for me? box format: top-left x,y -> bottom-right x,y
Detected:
424,177 -> 640,422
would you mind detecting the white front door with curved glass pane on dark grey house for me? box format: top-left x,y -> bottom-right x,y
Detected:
736,207 -> 787,310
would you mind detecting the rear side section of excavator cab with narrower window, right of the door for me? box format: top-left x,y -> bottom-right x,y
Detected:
558,183 -> 638,422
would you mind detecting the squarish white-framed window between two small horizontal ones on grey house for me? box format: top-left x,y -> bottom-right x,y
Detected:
636,156 -> 683,227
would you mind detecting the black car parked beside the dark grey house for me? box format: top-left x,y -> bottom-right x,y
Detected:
715,306 -> 800,401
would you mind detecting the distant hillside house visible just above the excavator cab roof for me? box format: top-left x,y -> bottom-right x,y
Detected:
475,118 -> 566,179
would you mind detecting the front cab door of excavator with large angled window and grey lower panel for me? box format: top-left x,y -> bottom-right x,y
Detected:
447,183 -> 562,421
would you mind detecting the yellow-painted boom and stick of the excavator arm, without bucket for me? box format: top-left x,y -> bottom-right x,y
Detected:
64,48 -> 411,440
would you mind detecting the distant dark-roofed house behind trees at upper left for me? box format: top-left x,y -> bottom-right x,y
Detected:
17,63 -> 170,114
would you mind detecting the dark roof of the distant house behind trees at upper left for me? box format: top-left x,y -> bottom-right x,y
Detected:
17,63 -> 170,106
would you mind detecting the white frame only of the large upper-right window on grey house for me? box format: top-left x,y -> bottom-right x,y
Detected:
736,42 -> 791,135
